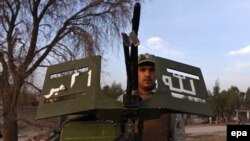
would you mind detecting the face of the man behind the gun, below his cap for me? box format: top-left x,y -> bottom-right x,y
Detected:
138,65 -> 156,90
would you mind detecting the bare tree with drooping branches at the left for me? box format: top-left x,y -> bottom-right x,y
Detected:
0,0 -> 139,141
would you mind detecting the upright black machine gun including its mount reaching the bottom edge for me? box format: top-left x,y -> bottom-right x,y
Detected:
115,3 -> 143,141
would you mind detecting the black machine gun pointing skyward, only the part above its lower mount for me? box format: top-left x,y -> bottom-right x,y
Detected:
122,3 -> 141,107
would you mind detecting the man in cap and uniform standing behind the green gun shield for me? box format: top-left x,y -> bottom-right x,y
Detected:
138,54 -> 186,141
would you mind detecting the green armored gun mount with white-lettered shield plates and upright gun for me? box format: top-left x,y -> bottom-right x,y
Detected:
36,4 -> 212,141
